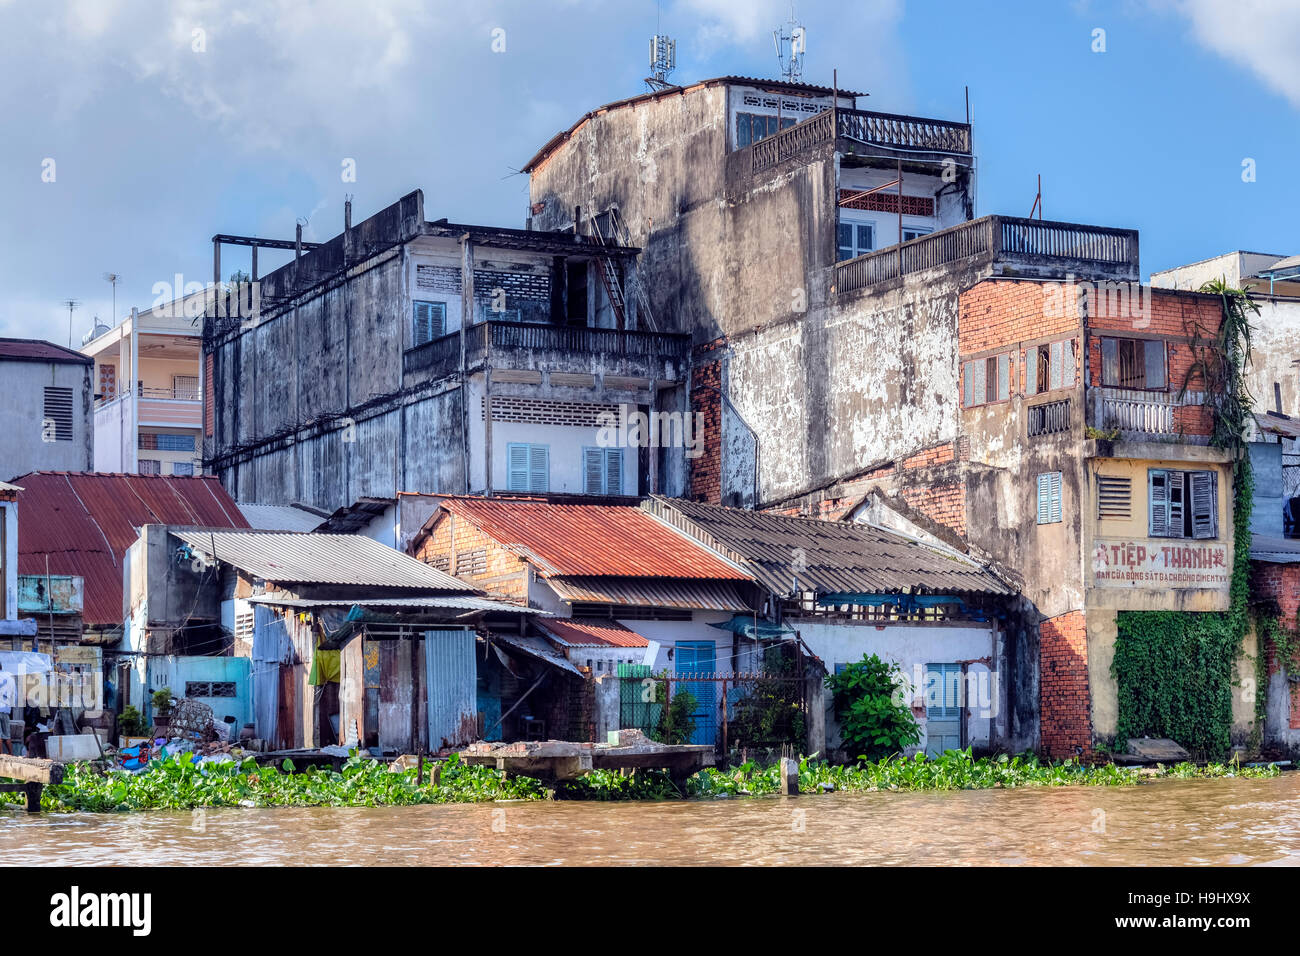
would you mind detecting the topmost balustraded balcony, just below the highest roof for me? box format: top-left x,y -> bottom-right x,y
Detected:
749,109 -> 971,173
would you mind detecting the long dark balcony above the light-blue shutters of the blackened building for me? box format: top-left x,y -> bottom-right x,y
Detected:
402,321 -> 690,378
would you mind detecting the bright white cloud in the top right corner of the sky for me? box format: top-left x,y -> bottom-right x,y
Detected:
1175,0 -> 1300,108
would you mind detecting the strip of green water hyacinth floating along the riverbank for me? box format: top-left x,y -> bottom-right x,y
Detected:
0,749 -> 1281,813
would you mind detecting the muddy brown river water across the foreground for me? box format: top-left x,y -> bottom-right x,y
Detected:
0,774 -> 1300,866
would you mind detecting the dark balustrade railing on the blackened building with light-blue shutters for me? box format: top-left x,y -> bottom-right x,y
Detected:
403,321 -> 690,375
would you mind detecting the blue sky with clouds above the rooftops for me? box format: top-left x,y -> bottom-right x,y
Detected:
0,0 -> 1300,342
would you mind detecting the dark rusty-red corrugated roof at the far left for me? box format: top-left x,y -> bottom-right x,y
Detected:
14,471 -> 248,627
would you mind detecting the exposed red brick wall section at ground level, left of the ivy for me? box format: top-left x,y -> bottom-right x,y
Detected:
1039,611 -> 1092,757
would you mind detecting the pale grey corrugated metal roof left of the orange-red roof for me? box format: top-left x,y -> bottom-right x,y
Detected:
172,531 -> 473,592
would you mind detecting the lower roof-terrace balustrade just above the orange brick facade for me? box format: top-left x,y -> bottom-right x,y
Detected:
832,215 -> 1139,295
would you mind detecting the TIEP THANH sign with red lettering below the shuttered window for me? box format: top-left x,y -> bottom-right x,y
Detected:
1092,538 -> 1232,589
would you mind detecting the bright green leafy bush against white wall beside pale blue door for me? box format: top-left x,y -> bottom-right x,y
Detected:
826,654 -> 920,760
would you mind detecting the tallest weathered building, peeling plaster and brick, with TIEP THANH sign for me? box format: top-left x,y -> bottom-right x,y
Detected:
525,77 -> 1248,754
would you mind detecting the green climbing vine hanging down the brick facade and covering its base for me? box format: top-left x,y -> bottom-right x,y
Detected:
1112,281 -> 1264,758
